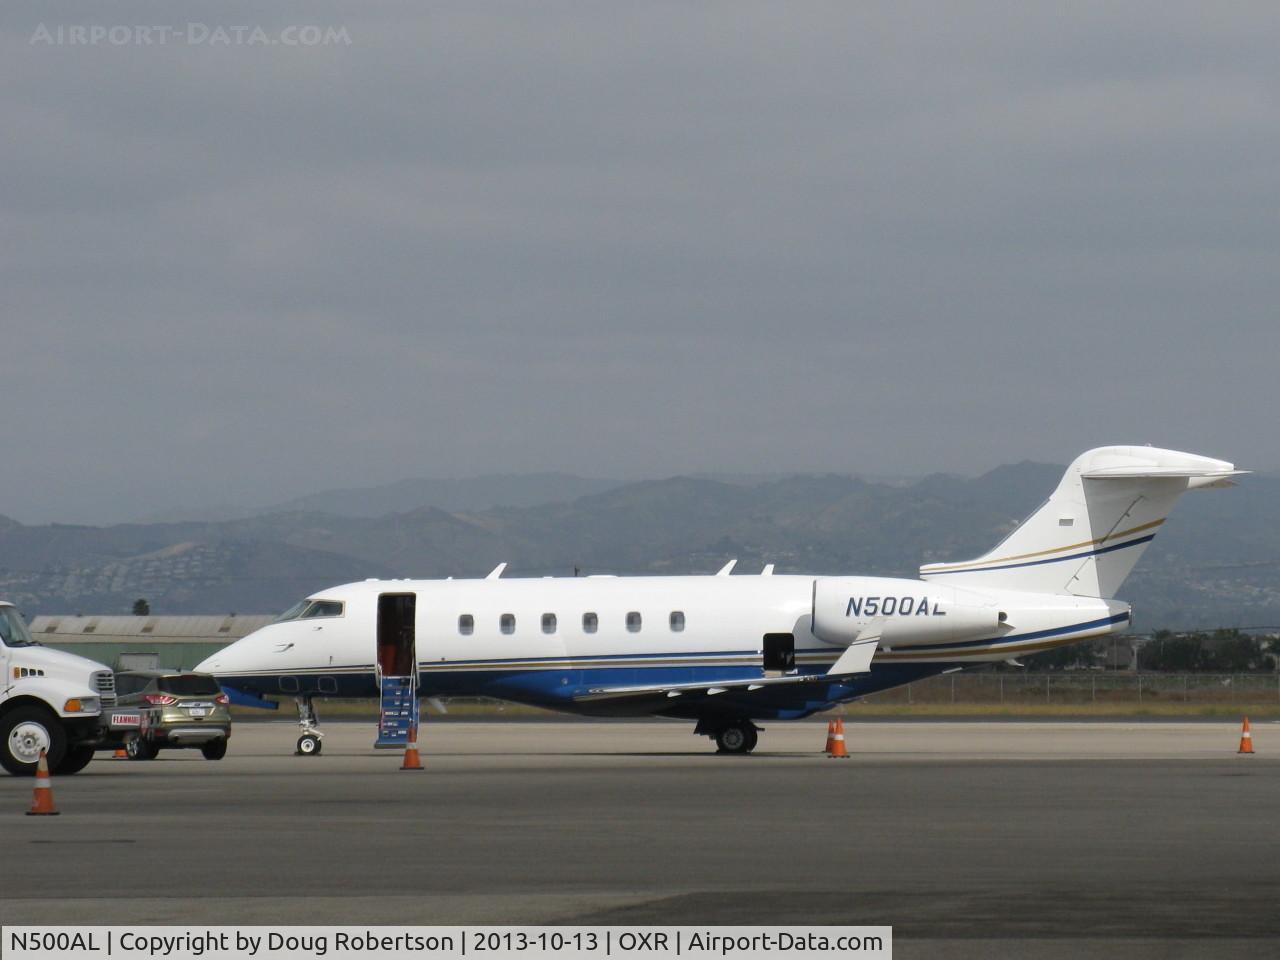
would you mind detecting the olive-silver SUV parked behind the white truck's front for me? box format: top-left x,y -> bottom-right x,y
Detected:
115,669 -> 232,760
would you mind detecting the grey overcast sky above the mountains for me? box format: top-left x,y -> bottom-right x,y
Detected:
0,0 -> 1280,522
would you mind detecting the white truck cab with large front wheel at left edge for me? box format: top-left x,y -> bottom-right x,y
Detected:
0,600 -> 138,776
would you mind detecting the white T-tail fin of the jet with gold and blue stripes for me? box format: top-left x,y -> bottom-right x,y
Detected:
920,447 -> 1247,598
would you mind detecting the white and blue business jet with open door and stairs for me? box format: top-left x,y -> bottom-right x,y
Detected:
197,447 -> 1243,754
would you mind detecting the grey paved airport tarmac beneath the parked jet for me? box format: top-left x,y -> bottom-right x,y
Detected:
0,718 -> 1280,960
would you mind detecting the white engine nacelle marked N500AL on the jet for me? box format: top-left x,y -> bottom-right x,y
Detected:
813,577 -> 1007,648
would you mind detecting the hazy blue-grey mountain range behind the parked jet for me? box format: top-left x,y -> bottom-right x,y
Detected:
0,462 -> 1280,630
